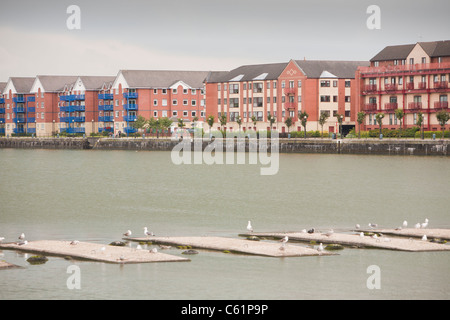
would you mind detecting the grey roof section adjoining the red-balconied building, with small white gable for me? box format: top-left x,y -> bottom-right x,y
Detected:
295,60 -> 369,79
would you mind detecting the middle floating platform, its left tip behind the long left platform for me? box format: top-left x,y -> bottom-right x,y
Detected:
123,237 -> 334,257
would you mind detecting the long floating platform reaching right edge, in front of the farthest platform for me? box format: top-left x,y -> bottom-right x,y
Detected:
241,230 -> 450,252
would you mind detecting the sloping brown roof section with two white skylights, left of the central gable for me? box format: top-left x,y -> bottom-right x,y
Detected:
208,62 -> 288,83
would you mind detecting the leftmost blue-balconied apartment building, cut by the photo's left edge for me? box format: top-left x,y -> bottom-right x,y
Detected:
0,77 -> 36,136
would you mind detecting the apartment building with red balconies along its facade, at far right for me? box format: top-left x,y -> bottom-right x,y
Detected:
356,40 -> 450,131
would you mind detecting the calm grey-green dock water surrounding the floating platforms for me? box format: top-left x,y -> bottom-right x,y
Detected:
0,149 -> 450,300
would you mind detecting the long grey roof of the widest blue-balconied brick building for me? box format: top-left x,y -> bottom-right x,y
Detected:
120,70 -> 210,88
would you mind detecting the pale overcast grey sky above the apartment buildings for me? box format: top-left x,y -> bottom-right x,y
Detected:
0,0 -> 450,82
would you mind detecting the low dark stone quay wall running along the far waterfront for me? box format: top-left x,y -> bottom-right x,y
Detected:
0,137 -> 450,156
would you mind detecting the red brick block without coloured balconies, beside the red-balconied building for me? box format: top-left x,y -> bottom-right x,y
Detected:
206,60 -> 369,132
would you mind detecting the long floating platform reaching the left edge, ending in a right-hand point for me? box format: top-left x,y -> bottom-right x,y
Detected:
0,240 -> 190,264
